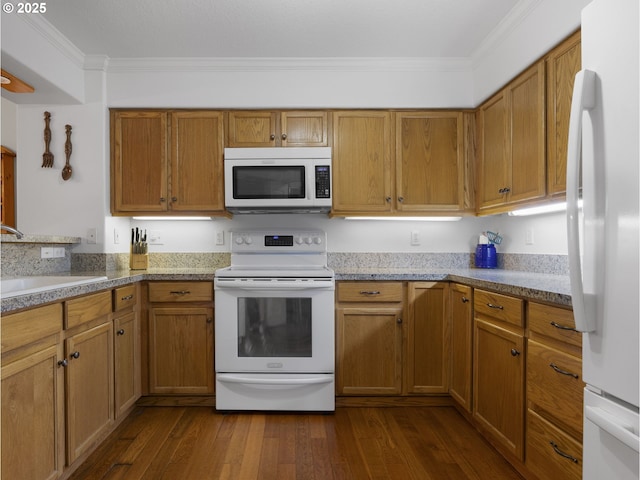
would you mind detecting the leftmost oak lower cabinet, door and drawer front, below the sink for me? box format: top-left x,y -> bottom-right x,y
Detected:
1,304 -> 65,480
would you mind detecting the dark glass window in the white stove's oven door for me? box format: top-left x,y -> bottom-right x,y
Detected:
238,297 -> 311,357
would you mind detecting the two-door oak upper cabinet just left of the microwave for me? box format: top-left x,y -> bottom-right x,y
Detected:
111,110 -> 224,215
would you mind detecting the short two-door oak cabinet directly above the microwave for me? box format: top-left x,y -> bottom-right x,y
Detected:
227,110 -> 329,147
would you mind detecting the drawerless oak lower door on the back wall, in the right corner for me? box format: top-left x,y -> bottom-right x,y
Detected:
405,282 -> 450,393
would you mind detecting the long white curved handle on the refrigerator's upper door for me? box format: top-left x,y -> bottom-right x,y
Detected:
567,70 -> 596,332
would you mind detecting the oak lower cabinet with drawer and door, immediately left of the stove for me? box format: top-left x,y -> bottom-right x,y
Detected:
148,282 -> 215,395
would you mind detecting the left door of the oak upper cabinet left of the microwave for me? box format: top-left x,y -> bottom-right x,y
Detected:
111,111 -> 168,214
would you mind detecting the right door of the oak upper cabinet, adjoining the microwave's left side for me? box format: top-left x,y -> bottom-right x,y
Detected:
169,111 -> 224,213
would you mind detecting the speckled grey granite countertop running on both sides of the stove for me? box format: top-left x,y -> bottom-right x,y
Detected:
0,267 -> 571,313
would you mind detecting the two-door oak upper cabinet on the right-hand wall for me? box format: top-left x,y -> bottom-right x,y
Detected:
477,61 -> 546,214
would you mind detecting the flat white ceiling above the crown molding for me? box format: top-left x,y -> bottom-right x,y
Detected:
38,0 -> 520,58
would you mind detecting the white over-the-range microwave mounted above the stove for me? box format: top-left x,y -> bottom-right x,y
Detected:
224,147 -> 332,213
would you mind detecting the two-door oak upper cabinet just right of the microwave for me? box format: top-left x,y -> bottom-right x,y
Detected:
332,110 -> 472,216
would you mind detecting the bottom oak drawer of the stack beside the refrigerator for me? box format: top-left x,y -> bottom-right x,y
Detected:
525,410 -> 582,480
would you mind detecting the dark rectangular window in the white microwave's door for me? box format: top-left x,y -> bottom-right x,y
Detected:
233,165 -> 305,199
